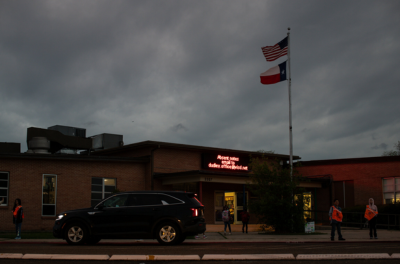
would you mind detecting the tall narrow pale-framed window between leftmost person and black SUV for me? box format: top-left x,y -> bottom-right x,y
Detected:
42,174 -> 57,216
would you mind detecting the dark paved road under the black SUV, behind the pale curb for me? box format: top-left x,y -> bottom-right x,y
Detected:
0,242 -> 400,256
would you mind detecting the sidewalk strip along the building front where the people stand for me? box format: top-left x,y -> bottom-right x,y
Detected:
0,228 -> 400,244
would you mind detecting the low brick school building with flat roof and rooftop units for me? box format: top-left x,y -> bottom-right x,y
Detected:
0,126 -> 400,231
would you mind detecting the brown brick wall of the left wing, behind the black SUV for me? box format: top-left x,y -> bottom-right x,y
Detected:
0,159 -> 146,230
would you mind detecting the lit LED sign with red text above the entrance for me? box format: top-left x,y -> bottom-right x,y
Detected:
203,154 -> 249,171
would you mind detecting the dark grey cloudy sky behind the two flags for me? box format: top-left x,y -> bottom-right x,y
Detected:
0,0 -> 400,160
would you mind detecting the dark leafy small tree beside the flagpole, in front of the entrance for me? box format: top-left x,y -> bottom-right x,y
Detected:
248,156 -> 305,233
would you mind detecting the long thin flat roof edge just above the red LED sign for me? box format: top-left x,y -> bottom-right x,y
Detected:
90,140 -> 301,160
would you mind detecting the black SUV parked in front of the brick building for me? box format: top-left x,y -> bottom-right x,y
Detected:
53,191 -> 206,245
